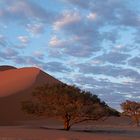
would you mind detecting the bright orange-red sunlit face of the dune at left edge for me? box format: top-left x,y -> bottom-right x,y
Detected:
0,68 -> 40,97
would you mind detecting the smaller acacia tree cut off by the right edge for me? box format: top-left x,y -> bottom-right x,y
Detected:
121,100 -> 140,126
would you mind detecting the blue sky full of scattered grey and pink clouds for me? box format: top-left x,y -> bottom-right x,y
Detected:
0,0 -> 140,110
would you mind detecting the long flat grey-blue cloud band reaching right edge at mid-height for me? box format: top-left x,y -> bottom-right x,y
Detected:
77,63 -> 140,80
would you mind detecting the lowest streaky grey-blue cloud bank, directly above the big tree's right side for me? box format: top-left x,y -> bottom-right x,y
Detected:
73,73 -> 140,110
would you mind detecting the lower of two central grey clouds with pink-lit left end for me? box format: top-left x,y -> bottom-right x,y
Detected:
49,36 -> 100,57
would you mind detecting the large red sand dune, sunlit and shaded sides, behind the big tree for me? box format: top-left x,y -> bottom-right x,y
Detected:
0,66 -> 60,123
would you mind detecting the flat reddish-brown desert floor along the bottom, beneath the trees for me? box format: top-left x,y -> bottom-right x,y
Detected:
0,125 -> 140,140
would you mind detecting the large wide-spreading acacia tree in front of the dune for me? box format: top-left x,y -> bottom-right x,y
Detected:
22,84 -> 119,130
